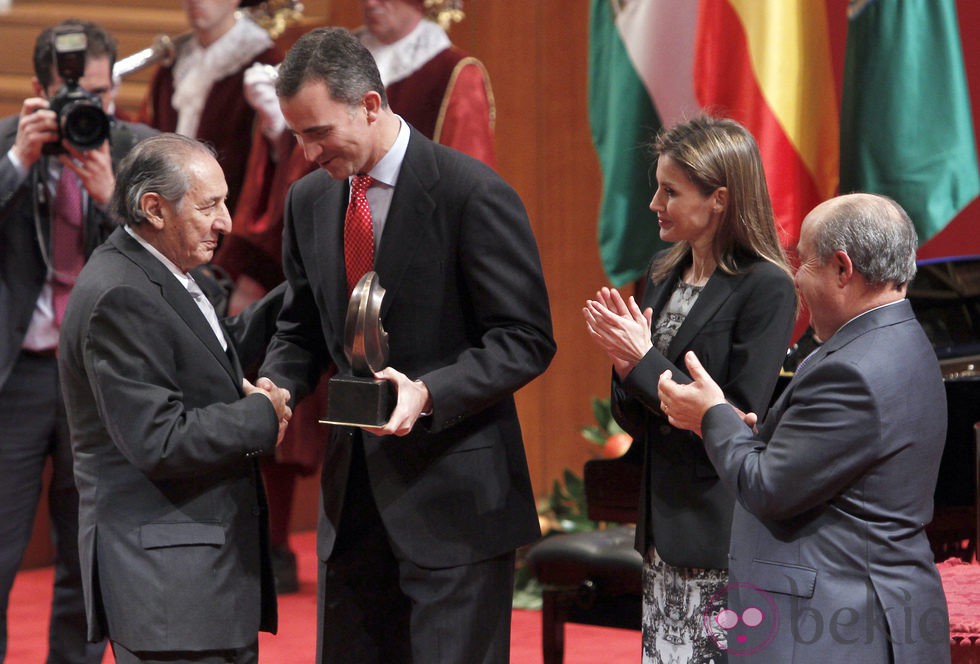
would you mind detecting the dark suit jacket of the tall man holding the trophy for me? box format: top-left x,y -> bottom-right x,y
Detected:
260,130 -> 555,567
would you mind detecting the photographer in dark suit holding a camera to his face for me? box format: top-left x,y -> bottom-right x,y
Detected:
0,21 -> 156,663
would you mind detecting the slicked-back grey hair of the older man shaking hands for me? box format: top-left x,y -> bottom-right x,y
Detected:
109,134 -> 215,226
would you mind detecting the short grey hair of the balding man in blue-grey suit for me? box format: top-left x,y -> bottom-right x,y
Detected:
814,194 -> 919,289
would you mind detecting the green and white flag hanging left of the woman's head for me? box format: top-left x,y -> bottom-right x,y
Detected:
589,0 -> 698,286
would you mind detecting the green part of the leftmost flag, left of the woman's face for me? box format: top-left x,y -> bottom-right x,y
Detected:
589,0 -> 666,286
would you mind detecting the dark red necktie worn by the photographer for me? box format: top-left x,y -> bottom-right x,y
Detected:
51,168 -> 85,325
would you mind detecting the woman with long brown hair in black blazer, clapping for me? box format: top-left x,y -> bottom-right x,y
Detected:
583,116 -> 797,664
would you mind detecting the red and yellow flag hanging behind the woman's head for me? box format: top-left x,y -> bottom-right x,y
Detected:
694,0 -> 839,252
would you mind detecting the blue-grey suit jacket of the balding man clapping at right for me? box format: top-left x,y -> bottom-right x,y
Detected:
702,301 -> 950,664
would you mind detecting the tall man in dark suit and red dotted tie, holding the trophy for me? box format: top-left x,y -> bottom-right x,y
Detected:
259,29 -> 555,664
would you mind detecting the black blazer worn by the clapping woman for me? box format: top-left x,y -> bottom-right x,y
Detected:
612,254 -> 796,569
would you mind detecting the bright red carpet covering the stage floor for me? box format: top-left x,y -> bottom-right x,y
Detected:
7,532 -> 640,664
